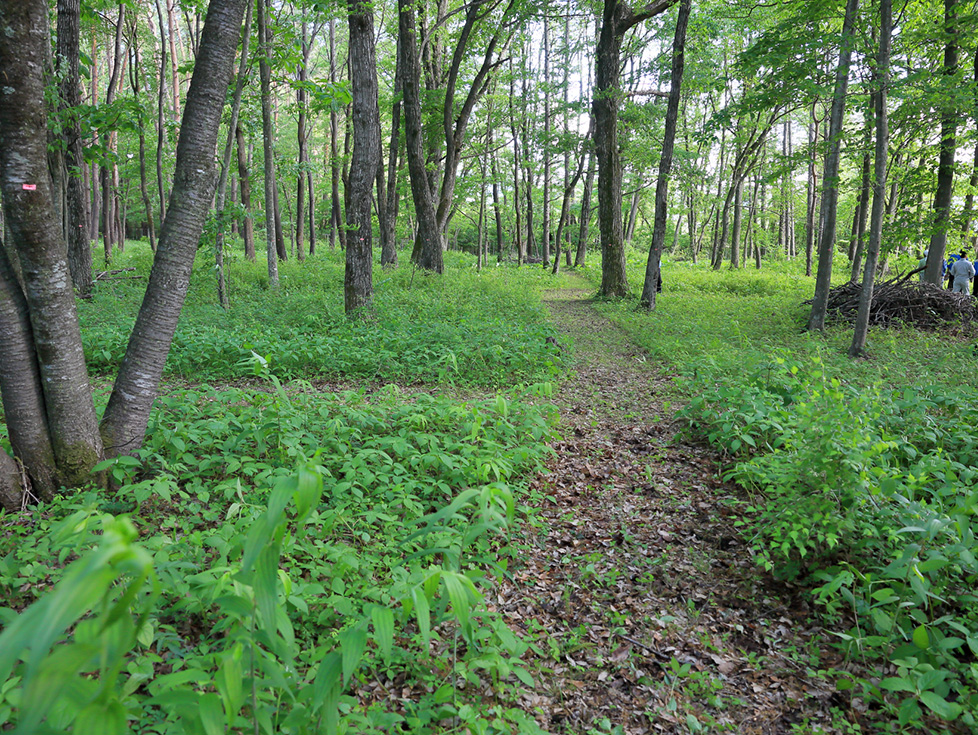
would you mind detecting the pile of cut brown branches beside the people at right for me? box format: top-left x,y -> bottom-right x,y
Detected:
805,269 -> 978,329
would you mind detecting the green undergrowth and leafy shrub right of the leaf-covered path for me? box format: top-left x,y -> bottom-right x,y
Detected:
576,254 -> 978,731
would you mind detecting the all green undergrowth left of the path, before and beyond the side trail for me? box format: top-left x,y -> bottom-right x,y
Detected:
0,245 -> 561,735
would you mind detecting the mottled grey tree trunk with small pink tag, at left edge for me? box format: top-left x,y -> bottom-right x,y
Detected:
0,0 -> 102,492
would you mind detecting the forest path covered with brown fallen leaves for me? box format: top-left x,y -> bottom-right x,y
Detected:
492,281 -> 842,735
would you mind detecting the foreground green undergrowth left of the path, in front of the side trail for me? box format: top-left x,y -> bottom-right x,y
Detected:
0,364 -> 554,735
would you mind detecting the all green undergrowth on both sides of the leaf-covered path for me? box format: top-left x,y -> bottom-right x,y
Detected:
7,244 -> 978,735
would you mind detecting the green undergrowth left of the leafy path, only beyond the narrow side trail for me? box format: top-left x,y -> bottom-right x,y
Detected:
80,243 -> 561,387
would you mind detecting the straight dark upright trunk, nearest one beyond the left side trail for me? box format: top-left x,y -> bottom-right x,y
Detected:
343,0 -> 380,315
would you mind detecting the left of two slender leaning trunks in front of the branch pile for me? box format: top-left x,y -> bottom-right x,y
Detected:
808,0 -> 856,332
